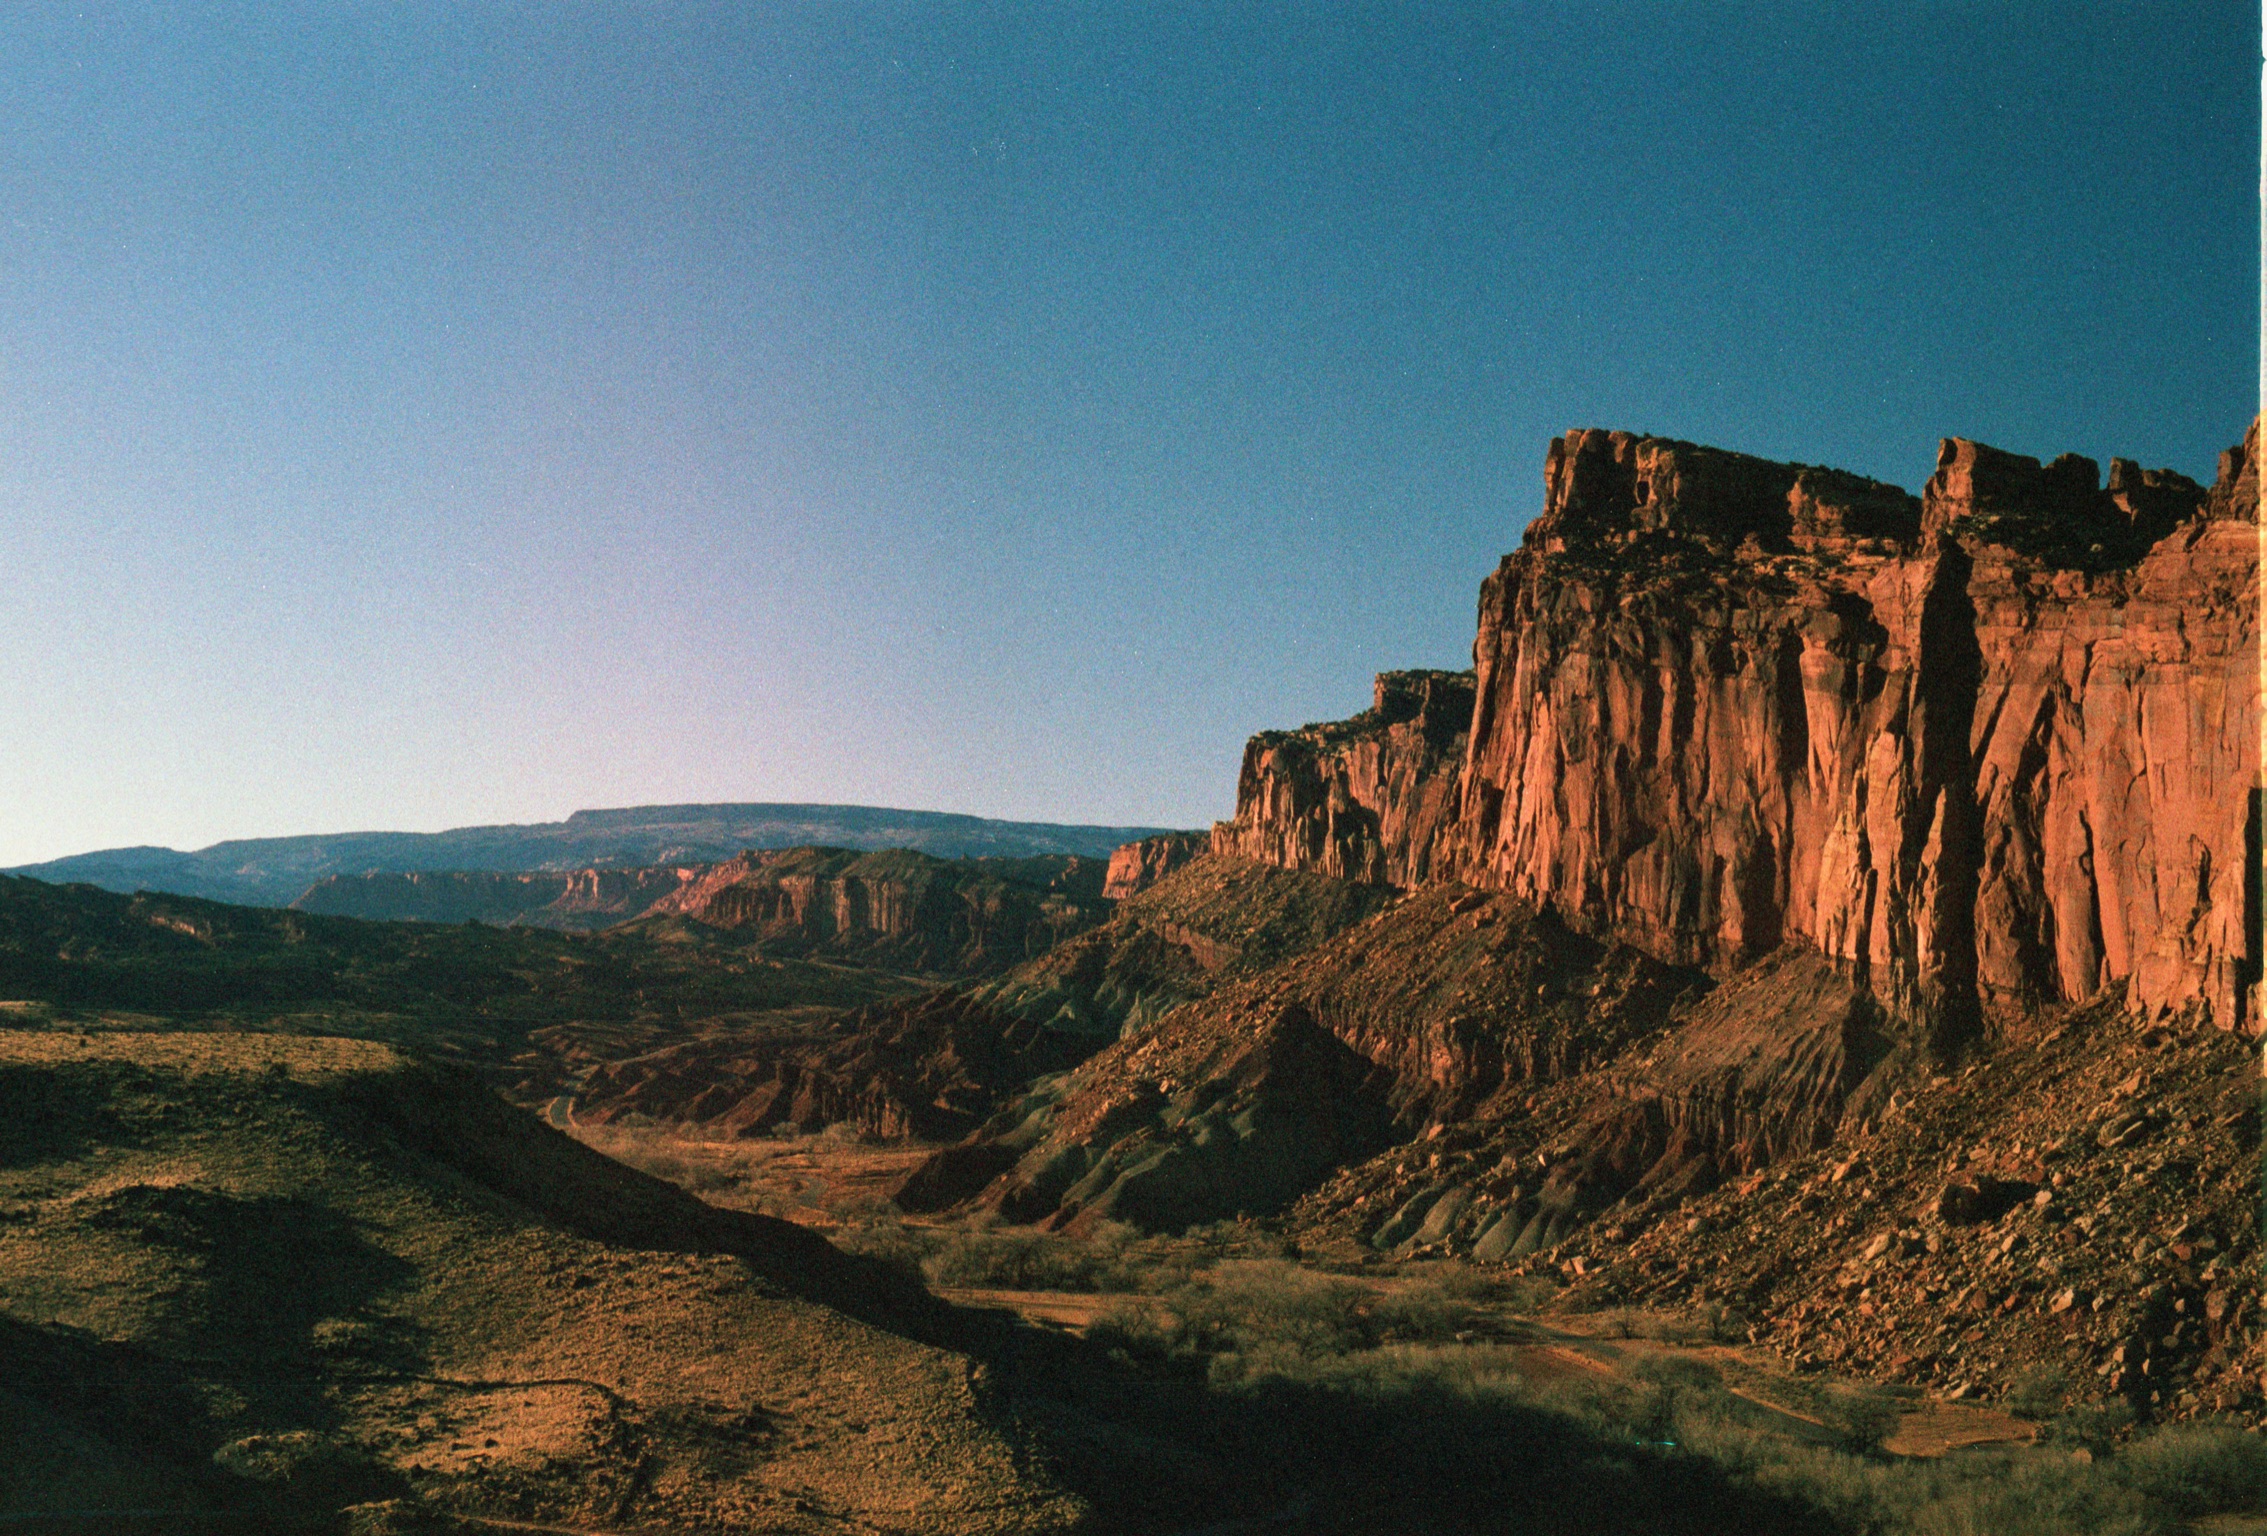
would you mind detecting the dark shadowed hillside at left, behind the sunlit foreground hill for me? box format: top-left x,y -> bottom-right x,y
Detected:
0,877 -> 925,1099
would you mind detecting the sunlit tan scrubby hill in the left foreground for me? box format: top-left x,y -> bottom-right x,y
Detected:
0,1031 -> 1079,1534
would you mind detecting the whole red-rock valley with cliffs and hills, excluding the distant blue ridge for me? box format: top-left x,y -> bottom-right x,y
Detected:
0,424 -> 2267,1536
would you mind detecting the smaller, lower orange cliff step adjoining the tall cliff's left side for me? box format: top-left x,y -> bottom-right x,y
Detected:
1213,671 -> 1474,886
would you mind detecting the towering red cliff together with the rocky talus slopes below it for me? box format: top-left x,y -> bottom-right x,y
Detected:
865,426 -> 2267,1423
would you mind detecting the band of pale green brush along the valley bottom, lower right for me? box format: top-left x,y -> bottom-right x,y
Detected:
1090,1313 -> 2203,1536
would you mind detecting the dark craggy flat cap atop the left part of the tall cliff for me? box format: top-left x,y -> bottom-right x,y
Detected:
1526,428 -> 1920,553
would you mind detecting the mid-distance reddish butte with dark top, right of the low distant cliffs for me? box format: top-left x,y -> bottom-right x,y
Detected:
648,847 -> 1111,976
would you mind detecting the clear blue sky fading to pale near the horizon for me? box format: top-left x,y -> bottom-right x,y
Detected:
0,0 -> 2260,863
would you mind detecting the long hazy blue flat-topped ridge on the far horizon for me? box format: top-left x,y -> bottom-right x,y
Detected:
7,802 -> 1168,906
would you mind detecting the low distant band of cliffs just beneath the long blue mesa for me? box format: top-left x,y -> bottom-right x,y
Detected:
290,865 -> 701,931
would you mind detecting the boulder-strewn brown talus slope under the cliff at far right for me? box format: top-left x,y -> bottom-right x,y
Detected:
1288,988 -> 2267,1420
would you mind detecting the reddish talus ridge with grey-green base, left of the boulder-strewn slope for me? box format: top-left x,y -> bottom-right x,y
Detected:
916,892 -> 1707,1228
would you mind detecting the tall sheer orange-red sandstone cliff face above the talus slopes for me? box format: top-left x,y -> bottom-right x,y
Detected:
1215,426 -> 2260,1033
